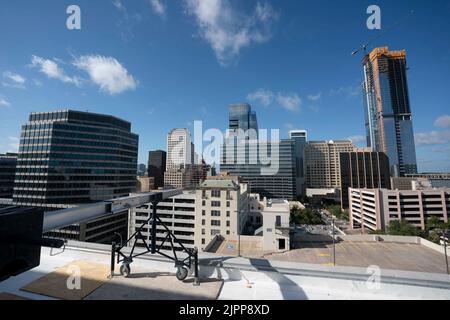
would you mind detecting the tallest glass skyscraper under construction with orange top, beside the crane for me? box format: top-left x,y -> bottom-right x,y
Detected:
363,47 -> 417,177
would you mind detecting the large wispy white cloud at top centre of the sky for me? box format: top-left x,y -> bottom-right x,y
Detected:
184,0 -> 278,65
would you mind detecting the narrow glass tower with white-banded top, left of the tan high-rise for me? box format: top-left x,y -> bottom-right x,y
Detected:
289,130 -> 308,195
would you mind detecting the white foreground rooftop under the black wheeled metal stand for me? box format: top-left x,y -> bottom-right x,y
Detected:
0,242 -> 450,301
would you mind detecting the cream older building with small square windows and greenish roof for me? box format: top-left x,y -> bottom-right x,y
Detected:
195,177 -> 249,251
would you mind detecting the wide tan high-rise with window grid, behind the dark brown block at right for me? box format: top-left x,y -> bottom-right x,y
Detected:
305,140 -> 356,189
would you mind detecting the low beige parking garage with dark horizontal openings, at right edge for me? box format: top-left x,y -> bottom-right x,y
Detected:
349,188 -> 450,232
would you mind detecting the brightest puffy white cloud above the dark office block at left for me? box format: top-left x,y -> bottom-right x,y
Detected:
73,55 -> 138,95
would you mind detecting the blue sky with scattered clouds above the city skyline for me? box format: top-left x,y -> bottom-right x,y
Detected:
0,0 -> 450,171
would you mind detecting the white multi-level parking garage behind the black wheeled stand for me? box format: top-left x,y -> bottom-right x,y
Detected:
128,191 -> 196,250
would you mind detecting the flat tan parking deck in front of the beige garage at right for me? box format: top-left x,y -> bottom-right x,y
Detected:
264,242 -> 450,273
